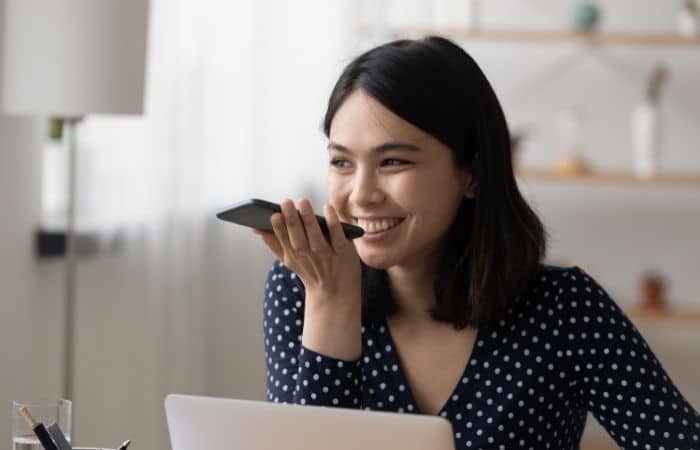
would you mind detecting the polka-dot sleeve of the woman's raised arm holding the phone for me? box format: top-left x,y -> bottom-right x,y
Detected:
263,261 -> 362,408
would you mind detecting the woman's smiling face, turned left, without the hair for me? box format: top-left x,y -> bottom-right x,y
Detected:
327,90 -> 472,269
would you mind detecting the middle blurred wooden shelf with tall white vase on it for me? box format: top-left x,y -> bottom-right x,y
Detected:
516,169 -> 700,187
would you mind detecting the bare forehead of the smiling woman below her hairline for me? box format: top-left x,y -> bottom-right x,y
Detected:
329,90 -> 430,149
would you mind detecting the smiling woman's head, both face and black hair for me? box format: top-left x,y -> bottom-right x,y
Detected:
323,38 -> 545,330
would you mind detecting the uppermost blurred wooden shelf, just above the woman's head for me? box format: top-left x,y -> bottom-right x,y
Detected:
361,26 -> 700,48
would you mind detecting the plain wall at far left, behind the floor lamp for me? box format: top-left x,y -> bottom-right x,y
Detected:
0,2 -> 63,440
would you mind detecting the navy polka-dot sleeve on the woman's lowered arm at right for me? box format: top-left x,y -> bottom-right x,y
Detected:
559,268 -> 700,450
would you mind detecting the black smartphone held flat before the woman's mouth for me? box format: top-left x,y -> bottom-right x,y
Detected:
216,198 -> 365,239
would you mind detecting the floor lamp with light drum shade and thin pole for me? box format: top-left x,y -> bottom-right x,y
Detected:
2,0 -> 148,426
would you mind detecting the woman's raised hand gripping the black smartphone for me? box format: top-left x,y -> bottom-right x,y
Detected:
254,199 -> 362,302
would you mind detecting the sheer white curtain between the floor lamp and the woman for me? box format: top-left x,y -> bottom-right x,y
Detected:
73,0 -> 359,449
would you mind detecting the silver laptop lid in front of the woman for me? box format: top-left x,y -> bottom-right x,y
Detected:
165,394 -> 454,450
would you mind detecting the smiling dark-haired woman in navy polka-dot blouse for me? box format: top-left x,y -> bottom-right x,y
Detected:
250,37 -> 700,449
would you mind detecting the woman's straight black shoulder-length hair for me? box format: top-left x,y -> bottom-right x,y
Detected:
323,36 -> 546,329
